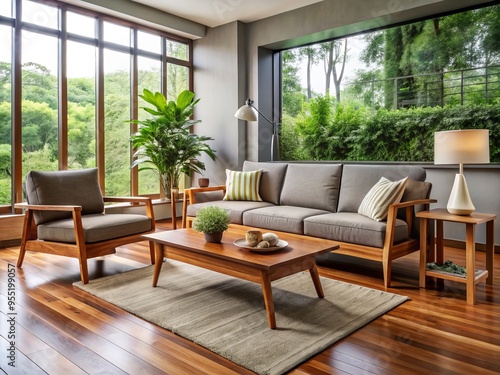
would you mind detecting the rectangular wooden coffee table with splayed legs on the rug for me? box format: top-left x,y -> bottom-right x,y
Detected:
143,225 -> 339,329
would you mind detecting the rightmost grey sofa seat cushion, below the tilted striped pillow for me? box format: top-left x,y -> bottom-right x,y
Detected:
304,212 -> 408,248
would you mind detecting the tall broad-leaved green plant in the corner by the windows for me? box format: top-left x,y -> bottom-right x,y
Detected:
130,89 -> 215,199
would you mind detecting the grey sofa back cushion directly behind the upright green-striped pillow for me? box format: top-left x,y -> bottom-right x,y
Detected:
242,160 -> 288,204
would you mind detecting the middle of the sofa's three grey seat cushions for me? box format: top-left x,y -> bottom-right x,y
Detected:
243,206 -> 328,234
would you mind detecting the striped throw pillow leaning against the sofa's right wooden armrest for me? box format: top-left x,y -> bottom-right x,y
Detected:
358,177 -> 408,221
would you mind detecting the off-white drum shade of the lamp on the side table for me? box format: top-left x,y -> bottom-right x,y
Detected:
434,129 -> 490,164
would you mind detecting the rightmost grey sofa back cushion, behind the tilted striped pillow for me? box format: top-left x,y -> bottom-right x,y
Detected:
338,164 -> 428,212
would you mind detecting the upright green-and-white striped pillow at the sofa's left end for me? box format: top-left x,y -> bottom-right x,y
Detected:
224,169 -> 262,202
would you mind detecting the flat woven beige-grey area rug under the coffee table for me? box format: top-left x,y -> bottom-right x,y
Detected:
73,260 -> 408,374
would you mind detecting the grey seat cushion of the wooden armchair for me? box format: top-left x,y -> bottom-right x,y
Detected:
37,214 -> 151,243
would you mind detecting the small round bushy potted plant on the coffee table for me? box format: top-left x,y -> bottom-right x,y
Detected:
193,206 -> 229,242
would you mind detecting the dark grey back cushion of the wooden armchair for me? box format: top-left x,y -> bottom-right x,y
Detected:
26,168 -> 104,225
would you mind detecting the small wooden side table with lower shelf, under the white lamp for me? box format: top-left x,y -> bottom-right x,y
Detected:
416,208 -> 496,305
